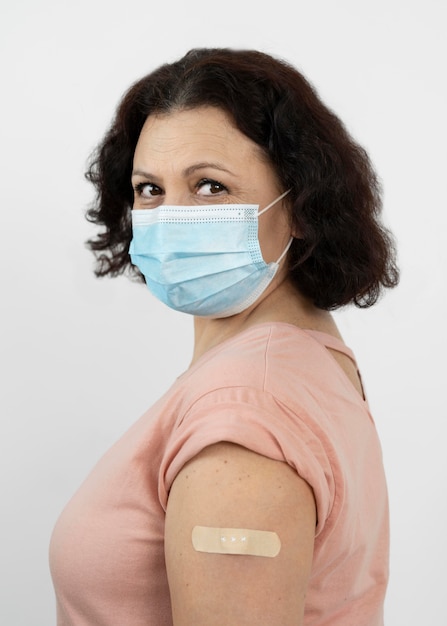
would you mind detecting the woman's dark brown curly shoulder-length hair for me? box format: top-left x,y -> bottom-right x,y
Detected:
86,48 -> 399,310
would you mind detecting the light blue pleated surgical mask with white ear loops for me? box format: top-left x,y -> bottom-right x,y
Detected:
129,191 -> 293,318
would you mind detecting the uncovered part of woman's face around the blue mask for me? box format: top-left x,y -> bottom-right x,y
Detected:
132,106 -> 291,263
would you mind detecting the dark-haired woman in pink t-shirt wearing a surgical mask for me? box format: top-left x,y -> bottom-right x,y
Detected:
51,49 -> 398,626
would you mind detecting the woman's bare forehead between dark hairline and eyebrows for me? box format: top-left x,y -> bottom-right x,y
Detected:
134,107 -> 265,166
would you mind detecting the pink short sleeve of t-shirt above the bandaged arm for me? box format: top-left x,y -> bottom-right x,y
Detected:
158,387 -> 335,535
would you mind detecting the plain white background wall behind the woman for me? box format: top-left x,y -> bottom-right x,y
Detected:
0,0 -> 447,626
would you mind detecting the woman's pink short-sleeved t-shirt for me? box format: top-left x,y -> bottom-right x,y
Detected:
50,323 -> 389,626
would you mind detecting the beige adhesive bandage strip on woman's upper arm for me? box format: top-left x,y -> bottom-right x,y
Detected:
192,526 -> 281,557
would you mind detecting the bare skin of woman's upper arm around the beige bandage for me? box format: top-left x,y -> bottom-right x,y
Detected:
165,442 -> 316,626
